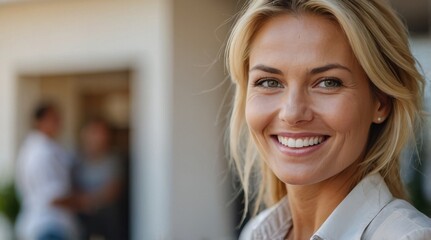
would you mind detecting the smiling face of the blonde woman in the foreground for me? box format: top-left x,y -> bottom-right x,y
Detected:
246,14 -> 384,185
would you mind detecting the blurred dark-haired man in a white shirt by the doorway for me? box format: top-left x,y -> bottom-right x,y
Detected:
16,104 -> 82,240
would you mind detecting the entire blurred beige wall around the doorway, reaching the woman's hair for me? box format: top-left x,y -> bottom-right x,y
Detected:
0,0 -> 239,240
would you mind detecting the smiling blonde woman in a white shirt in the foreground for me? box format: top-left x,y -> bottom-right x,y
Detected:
227,0 -> 431,239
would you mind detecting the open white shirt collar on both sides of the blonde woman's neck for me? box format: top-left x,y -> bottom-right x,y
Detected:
252,173 -> 393,240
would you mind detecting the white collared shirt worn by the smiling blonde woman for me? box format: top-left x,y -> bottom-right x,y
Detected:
240,174 -> 431,240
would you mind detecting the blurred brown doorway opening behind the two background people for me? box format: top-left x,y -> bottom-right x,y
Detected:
16,69 -> 132,239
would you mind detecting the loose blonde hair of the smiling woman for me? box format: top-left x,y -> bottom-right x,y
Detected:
226,0 -> 424,218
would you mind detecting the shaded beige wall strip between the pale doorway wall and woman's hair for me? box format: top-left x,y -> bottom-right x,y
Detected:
170,0 -> 238,239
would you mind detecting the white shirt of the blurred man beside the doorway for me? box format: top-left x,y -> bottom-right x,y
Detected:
16,131 -> 78,240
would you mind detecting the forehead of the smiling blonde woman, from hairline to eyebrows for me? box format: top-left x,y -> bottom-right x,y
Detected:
250,14 -> 355,68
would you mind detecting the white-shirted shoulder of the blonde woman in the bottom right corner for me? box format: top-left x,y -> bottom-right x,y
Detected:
365,199 -> 431,240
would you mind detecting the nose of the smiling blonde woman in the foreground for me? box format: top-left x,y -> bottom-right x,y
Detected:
279,87 -> 313,126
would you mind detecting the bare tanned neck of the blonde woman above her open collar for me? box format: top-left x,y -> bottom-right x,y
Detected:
286,164 -> 358,239
